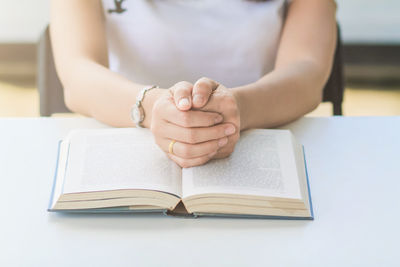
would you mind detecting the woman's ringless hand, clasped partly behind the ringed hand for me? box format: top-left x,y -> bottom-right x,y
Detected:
173,78 -> 240,158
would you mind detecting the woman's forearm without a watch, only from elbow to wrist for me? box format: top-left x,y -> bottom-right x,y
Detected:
232,61 -> 326,130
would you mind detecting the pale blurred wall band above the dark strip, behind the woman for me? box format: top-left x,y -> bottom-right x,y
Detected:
0,0 -> 400,44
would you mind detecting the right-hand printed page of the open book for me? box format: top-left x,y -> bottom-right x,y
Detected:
182,129 -> 301,199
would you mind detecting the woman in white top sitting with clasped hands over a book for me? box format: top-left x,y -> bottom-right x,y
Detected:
50,0 -> 336,167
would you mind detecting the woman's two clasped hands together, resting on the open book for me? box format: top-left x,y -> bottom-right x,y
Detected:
150,78 -> 240,168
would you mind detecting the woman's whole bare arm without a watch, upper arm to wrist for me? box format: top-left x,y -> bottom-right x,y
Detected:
233,0 -> 337,129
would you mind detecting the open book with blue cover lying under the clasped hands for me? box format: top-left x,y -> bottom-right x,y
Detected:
49,128 -> 313,219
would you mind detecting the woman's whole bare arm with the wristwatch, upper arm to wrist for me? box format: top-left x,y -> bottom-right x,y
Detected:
50,0 -> 163,127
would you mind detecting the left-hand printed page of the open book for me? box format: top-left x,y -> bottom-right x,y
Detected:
63,129 -> 182,197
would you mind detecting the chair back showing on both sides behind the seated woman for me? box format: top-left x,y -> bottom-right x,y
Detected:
37,27 -> 344,116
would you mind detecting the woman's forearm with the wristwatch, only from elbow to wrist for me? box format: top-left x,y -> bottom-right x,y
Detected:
60,59 -> 160,127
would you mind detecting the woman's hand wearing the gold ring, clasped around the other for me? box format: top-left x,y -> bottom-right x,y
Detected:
150,82 -> 238,168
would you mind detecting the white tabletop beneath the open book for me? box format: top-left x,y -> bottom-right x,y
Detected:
0,117 -> 400,266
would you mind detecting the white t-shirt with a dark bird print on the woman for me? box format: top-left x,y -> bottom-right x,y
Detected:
103,0 -> 287,88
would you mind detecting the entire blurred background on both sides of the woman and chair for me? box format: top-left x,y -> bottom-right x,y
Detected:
0,0 -> 400,117
